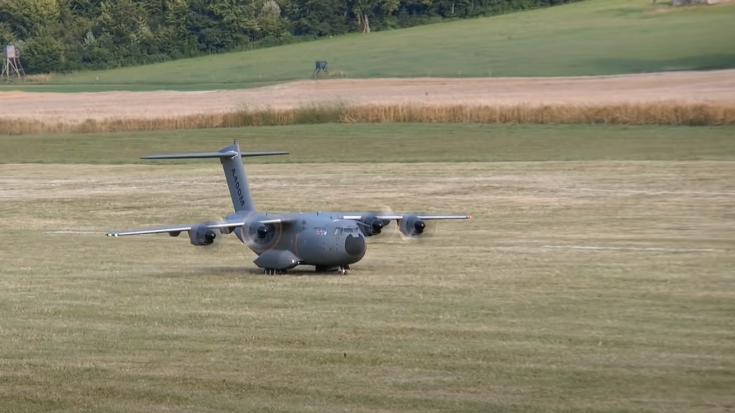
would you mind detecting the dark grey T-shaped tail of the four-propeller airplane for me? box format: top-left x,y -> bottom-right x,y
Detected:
141,141 -> 288,211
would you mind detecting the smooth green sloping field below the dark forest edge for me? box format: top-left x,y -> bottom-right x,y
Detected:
5,0 -> 735,91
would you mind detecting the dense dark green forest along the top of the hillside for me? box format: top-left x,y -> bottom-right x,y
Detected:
0,0 -> 580,73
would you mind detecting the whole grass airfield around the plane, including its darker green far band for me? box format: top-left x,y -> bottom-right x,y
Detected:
0,125 -> 735,412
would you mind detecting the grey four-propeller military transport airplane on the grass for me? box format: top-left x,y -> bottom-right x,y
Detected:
106,141 -> 472,275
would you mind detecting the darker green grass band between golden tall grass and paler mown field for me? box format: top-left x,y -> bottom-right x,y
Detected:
0,124 -> 735,164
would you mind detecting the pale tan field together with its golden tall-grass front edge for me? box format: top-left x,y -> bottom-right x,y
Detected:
0,70 -> 735,134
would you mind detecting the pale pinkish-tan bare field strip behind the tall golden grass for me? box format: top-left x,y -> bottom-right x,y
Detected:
0,70 -> 735,123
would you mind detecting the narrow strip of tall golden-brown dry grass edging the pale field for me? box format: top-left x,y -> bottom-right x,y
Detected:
0,102 -> 735,135
